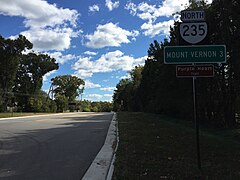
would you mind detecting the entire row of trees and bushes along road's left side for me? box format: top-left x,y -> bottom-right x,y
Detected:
0,35 -> 112,114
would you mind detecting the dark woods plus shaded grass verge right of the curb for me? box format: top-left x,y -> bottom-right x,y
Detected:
113,0 -> 240,180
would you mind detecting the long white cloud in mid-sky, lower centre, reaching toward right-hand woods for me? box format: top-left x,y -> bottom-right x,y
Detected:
72,50 -> 147,78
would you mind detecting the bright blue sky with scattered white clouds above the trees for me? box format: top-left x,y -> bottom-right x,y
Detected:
0,0 -> 210,101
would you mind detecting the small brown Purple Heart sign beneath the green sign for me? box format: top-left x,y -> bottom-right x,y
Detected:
176,65 -> 214,77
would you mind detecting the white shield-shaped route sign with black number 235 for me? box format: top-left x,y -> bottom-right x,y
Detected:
180,22 -> 207,44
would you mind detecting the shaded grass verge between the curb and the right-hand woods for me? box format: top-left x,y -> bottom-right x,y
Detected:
113,112 -> 240,180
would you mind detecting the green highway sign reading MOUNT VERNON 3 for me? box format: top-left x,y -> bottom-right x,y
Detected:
164,45 -> 226,64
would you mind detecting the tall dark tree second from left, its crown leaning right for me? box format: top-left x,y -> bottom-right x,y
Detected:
13,53 -> 59,111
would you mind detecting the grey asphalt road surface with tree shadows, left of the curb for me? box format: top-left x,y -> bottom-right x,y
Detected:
0,113 -> 113,180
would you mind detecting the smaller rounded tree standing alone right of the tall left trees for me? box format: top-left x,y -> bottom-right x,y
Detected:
51,75 -> 85,102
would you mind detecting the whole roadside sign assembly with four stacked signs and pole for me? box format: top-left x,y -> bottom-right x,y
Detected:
164,10 -> 226,170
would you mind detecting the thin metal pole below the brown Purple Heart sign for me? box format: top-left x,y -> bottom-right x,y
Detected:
193,74 -> 202,170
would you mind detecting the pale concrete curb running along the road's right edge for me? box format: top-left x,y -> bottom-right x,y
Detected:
82,113 -> 117,180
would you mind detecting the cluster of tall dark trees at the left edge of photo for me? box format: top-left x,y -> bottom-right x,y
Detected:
0,35 -> 58,112
